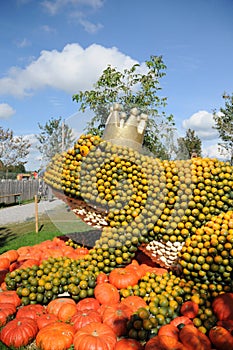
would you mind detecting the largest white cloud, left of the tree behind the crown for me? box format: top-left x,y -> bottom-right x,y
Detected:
0,43 -> 137,97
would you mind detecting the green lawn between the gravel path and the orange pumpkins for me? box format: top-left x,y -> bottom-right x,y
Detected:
0,206 -> 93,254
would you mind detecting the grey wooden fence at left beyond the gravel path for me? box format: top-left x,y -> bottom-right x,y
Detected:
0,179 -> 39,204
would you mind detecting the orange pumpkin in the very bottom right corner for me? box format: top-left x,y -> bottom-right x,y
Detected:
209,326 -> 233,350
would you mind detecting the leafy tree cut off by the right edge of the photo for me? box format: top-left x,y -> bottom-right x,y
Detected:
213,93 -> 233,165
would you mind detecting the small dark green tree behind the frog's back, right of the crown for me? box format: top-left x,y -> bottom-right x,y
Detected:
176,129 -> 201,159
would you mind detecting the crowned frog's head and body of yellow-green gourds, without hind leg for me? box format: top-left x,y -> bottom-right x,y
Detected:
45,135 -> 233,274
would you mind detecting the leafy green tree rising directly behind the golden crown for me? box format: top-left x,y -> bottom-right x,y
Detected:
73,56 -> 174,155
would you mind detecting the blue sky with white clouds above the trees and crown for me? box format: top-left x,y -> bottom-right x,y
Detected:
0,0 -> 233,170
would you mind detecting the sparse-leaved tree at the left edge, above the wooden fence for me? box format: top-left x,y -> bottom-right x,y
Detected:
0,127 -> 31,169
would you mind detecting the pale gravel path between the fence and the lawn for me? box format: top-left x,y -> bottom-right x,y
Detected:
0,199 -> 65,226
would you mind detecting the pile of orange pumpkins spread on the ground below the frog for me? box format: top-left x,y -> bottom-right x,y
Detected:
0,238 -> 233,350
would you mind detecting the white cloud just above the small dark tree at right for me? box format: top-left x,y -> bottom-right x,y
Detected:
182,111 -> 218,140
